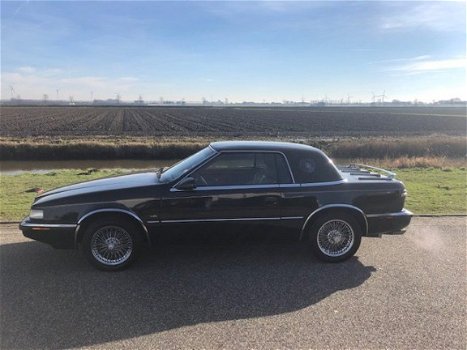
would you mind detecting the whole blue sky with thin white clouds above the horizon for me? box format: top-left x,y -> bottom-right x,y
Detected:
1,1 -> 467,102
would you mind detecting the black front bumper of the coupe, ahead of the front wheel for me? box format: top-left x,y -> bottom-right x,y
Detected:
19,217 -> 77,249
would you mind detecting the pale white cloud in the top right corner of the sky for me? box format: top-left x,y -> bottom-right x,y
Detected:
380,2 -> 465,31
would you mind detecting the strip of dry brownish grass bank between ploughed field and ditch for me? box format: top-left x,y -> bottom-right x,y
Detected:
0,135 -> 467,161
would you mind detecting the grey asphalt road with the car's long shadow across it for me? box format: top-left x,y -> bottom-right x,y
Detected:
0,217 -> 466,349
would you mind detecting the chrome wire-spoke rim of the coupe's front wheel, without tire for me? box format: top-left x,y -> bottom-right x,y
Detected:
91,226 -> 133,266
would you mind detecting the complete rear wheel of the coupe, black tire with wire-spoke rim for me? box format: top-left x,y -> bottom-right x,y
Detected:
309,213 -> 362,262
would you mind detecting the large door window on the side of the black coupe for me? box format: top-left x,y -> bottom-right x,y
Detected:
191,152 -> 291,187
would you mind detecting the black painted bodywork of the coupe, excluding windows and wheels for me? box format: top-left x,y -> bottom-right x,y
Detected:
20,142 -> 411,248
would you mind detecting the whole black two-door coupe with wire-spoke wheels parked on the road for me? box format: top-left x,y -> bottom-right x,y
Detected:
20,141 -> 412,270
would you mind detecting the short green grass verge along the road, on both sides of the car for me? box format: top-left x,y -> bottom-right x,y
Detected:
0,168 -> 467,221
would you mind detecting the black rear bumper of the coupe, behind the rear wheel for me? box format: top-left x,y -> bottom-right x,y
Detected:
366,209 -> 413,237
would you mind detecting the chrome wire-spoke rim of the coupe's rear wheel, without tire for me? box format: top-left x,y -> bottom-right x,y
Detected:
316,219 -> 355,257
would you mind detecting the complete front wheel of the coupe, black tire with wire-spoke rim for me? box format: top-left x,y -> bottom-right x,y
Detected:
82,217 -> 142,271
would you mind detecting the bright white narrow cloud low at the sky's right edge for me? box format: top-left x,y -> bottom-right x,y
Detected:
389,56 -> 466,74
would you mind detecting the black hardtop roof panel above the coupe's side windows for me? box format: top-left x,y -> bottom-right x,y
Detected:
210,141 -> 322,153
